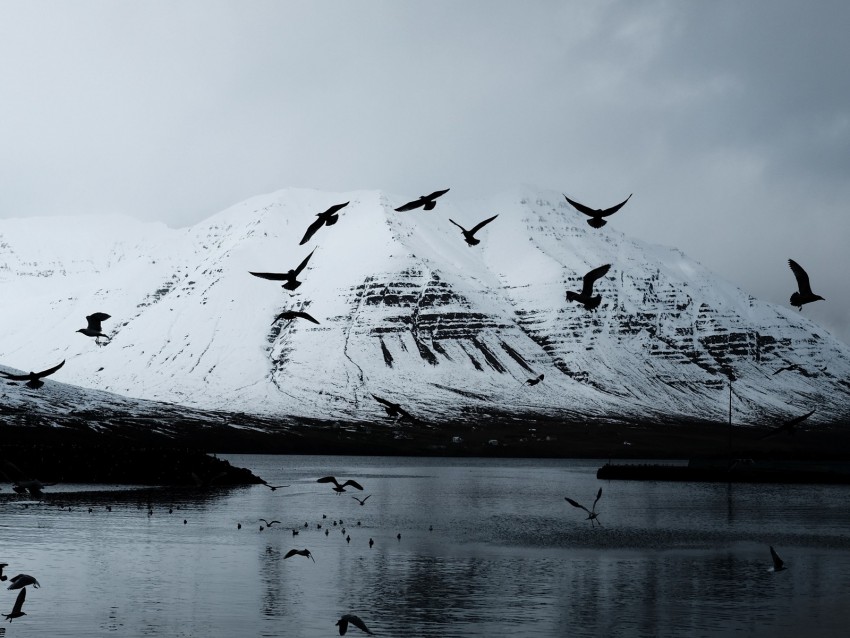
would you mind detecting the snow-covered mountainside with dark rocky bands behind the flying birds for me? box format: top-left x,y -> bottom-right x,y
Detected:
0,185 -> 850,430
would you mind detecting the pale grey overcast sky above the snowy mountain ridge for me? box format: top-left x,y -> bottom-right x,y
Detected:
0,0 -> 850,342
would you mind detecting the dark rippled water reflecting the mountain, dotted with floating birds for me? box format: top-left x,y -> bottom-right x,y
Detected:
0,456 -> 850,638
